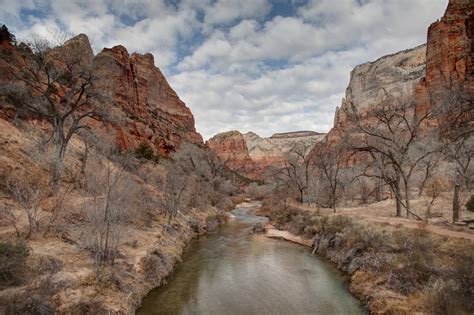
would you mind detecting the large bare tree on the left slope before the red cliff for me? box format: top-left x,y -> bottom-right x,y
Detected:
2,31 -> 105,192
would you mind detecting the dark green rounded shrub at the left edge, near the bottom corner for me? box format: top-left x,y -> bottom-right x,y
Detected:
0,242 -> 29,285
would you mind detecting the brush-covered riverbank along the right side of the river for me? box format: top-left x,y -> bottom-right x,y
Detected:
265,204 -> 474,314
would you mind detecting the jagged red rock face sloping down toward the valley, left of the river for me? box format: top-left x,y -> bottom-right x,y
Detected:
94,46 -> 203,154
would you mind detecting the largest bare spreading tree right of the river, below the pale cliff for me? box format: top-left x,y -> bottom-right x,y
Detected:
345,93 -> 440,220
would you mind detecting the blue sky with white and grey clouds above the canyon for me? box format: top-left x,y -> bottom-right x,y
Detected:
0,0 -> 448,139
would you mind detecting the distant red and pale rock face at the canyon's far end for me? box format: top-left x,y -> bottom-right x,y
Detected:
207,131 -> 324,179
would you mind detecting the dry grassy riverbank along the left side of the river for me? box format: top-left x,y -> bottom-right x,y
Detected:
0,208 -> 228,314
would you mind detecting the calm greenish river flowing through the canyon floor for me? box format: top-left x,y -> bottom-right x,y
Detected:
137,203 -> 365,315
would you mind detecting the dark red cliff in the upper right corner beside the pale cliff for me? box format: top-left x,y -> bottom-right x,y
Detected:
417,0 -> 474,131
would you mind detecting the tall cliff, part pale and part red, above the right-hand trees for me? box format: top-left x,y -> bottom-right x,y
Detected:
328,0 -> 474,149
